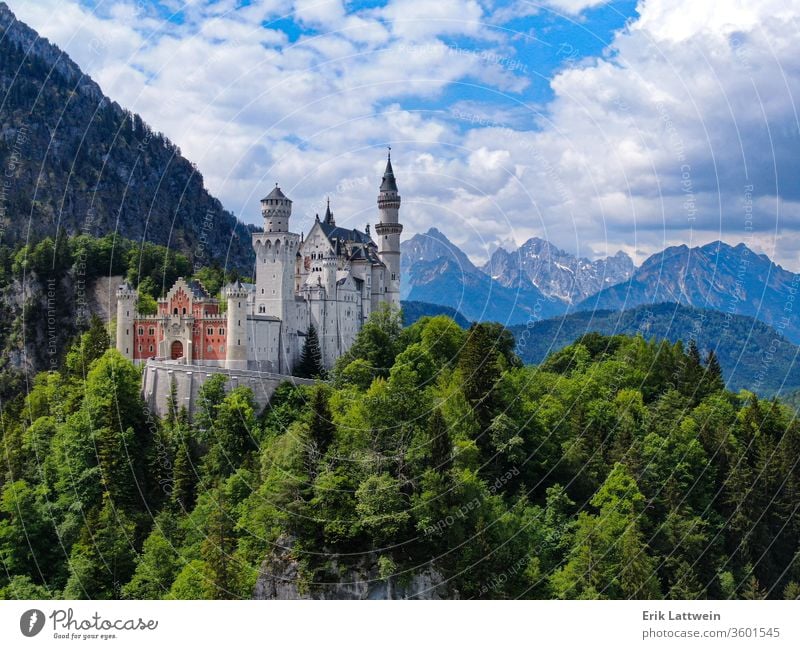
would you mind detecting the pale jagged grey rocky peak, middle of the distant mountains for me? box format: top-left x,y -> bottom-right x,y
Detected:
483,237 -> 635,304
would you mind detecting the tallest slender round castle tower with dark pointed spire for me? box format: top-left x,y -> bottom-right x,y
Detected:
375,147 -> 403,309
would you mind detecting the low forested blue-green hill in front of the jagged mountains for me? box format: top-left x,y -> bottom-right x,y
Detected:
511,304 -> 800,394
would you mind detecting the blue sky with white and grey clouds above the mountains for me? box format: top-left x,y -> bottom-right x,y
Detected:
8,0 -> 800,270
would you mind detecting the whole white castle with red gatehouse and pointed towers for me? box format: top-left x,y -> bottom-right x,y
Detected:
116,150 -> 403,380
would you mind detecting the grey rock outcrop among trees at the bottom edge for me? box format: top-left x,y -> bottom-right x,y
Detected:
253,539 -> 458,599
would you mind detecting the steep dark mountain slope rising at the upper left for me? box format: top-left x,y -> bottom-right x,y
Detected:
0,2 -> 254,274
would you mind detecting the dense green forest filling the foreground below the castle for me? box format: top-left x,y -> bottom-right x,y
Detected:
0,310 -> 800,599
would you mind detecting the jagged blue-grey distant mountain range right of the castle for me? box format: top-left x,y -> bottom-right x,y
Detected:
401,228 -> 800,343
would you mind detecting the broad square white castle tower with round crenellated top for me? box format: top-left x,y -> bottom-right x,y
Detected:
253,185 -> 300,322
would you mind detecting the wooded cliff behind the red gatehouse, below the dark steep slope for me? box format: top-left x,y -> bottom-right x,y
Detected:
0,230 -> 238,404
